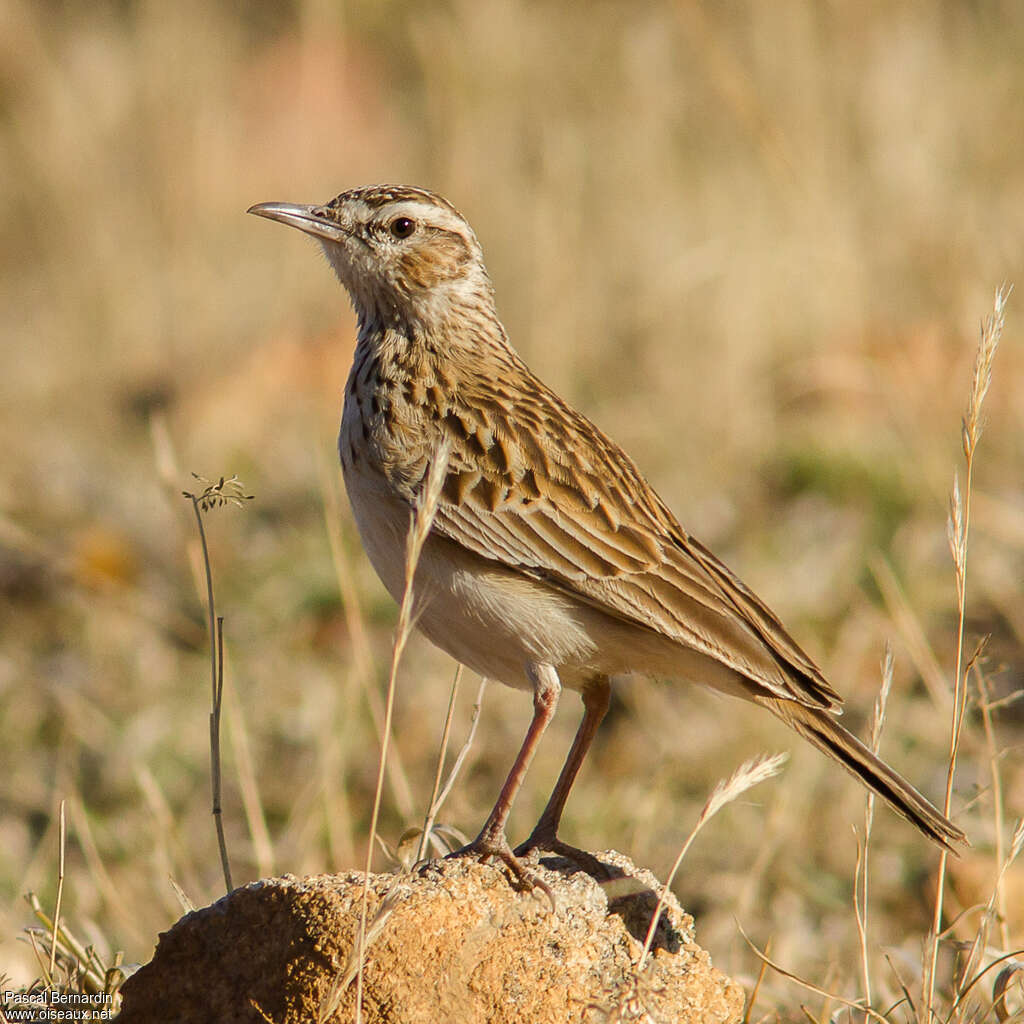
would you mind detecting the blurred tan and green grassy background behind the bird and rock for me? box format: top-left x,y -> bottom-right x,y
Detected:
0,0 -> 1024,1006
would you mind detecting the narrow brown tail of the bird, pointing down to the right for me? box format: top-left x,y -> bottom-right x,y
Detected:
758,697 -> 967,853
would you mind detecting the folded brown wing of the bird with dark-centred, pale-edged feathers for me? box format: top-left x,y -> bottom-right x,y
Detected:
423,368 -> 842,711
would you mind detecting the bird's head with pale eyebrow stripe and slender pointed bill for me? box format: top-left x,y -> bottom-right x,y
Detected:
249,185 -> 494,329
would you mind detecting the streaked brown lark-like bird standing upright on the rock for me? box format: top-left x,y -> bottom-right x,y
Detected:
248,184 -> 966,882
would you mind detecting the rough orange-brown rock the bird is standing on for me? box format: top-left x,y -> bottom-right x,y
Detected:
118,852 -> 743,1024
